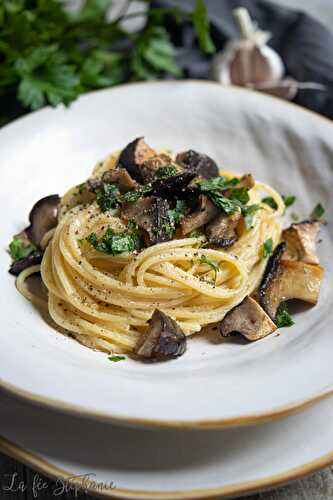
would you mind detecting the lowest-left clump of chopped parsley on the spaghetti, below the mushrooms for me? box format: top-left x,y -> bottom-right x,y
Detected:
86,225 -> 140,255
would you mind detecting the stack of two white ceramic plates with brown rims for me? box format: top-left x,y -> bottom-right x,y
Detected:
0,81 -> 333,499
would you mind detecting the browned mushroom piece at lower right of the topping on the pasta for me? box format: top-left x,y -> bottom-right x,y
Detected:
206,211 -> 242,248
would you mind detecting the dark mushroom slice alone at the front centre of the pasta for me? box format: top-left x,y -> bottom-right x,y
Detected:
136,309 -> 186,360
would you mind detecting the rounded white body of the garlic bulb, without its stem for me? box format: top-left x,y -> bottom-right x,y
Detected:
211,40 -> 285,86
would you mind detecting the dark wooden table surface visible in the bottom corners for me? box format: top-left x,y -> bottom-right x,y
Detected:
0,454 -> 333,500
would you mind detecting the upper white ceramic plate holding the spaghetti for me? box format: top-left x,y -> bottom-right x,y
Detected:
0,81 -> 333,427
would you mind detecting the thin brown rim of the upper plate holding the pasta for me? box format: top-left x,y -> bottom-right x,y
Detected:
0,79 -> 333,430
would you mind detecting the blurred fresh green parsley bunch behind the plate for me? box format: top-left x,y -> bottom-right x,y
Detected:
0,0 -> 214,123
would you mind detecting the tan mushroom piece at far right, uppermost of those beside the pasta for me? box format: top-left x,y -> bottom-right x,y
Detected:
282,221 -> 321,264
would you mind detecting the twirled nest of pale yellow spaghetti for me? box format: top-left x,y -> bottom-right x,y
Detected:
17,150 -> 284,353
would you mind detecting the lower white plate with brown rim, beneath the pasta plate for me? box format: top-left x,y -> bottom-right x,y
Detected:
0,391 -> 333,500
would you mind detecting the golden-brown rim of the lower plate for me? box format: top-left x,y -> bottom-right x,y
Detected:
0,435 -> 333,500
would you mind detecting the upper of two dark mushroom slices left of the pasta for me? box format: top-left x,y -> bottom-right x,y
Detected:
25,194 -> 60,246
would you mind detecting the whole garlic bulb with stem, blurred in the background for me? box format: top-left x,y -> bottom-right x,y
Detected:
211,7 -> 285,86
